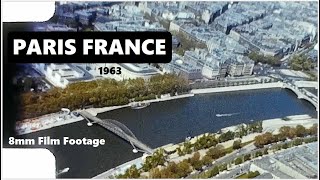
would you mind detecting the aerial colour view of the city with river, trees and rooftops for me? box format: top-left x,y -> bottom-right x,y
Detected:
6,1 -> 319,179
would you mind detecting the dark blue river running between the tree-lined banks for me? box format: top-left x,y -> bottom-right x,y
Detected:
20,89 -> 316,178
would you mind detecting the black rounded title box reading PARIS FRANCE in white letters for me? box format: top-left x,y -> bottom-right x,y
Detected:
7,32 -> 172,63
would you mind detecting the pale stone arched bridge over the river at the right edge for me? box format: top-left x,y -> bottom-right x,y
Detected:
283,82 -> 319,111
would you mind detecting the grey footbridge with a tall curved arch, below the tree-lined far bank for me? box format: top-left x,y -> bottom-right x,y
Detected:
78,111 -> 153,154
